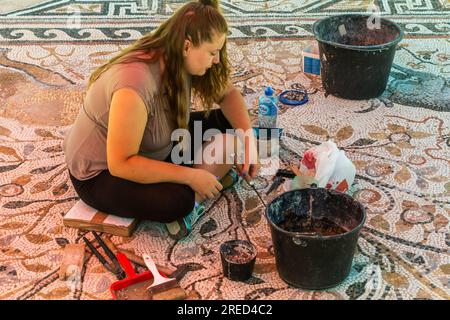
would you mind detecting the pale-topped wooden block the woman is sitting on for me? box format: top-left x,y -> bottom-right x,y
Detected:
63,200 -> 138,237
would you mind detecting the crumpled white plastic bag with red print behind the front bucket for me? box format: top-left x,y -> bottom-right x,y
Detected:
291,140 -> 356,192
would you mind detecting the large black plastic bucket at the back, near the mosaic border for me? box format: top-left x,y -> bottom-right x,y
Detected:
313,14 -> 403,100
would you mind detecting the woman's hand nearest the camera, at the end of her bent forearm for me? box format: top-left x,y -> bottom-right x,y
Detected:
188,169 -> 223,199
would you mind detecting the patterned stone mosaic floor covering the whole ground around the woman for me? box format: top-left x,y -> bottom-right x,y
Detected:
0,0 -> 450,300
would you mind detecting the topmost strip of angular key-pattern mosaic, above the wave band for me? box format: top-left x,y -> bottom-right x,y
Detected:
0,0 -> 450,19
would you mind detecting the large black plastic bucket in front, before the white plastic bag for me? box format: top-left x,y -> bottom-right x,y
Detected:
266,188 -> 366,290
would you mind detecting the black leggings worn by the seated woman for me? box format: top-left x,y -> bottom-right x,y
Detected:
69,109 -> 232,223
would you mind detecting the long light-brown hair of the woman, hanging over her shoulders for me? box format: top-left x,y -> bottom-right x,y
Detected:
89,0 -> 230,128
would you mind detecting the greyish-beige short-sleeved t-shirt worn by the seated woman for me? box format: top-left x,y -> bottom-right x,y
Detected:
64,62 -> 186,180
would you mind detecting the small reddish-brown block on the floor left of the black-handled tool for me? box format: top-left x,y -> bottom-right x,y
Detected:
59,244 -> 85,280
